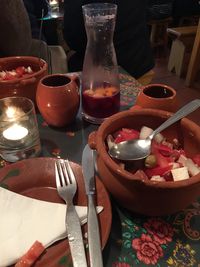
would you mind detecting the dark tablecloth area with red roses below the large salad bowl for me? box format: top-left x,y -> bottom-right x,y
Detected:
112,199 -> 200,267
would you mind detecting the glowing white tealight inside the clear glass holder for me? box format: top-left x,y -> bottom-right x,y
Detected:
3,124 -> 28,141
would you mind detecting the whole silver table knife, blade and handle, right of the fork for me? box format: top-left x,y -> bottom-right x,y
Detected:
82,145 -> 103,267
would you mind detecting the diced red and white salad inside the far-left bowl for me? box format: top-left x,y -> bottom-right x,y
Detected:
0,66 -> 33,81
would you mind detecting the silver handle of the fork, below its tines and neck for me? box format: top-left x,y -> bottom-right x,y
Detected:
66,204 -> 87,267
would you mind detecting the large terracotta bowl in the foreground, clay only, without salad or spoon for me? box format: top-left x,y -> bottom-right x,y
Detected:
89,109 -> 200,216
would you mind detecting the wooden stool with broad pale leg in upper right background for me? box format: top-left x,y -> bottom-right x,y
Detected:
167,26 -> 197,76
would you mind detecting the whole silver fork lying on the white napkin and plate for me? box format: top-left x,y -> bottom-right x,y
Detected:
55,160 -> 87,267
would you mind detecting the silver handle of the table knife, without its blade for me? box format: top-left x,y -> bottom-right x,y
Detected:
88,194 -> 103,267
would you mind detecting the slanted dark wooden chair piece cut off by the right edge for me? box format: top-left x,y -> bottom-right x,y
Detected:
186,19 -> 200,86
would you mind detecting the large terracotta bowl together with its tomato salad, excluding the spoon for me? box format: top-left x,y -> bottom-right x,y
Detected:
89,109 -> 200,216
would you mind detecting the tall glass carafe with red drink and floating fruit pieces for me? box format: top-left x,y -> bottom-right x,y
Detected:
82,3 -> 120,124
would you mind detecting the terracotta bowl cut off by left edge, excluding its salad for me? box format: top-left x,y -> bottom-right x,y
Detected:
0,56 -> 48,102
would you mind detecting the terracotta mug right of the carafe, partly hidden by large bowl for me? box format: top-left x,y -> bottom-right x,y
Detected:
131,84 -> 177,112
